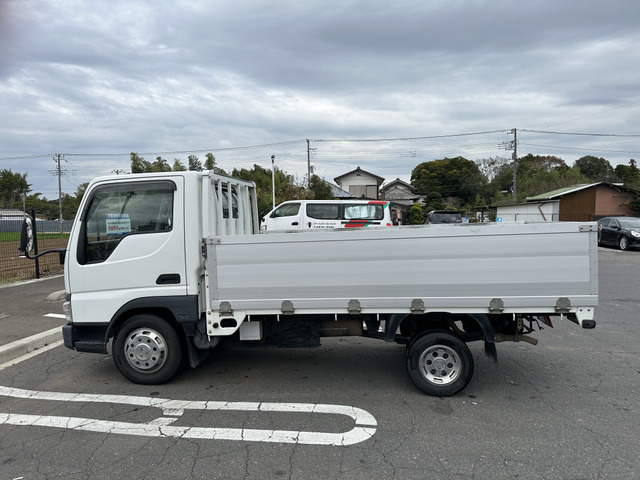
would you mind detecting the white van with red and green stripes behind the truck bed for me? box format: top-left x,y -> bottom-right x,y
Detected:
260,200 -> 391,233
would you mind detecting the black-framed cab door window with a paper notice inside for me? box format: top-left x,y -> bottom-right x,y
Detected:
78,181 -> 176,264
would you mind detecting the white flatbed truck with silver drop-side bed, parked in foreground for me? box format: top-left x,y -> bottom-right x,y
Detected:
21,172 -> 598,396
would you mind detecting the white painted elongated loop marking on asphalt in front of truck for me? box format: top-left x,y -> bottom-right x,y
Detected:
0,385 -> 377,446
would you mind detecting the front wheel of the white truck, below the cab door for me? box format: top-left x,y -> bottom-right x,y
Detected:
113,314 -> 182,385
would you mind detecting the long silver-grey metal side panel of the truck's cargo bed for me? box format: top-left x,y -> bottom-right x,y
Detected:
206,222 -> 598,335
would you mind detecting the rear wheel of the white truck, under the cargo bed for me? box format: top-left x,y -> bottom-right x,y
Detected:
407,330 -> 473,397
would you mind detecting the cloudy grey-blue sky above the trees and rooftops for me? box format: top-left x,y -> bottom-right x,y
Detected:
0,0 -> 640,199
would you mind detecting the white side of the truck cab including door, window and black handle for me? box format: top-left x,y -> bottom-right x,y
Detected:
65,176 -> 187,323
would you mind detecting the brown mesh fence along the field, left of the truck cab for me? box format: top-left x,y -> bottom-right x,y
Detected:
0,219 -> 73,284
